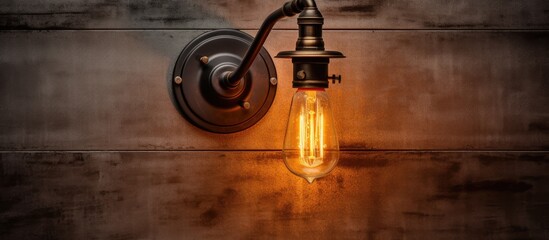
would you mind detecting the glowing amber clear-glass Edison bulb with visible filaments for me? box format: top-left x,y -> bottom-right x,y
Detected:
282,88 -> 339,183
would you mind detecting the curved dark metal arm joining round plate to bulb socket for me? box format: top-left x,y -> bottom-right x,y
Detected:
225,0 -> 308,87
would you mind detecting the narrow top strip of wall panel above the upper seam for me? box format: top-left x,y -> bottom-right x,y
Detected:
0,0 -> 549,29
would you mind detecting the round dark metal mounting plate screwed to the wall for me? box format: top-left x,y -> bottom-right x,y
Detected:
171,29 -> 277,133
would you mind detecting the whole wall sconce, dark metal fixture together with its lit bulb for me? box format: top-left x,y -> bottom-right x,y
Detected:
172,0 -> 345,183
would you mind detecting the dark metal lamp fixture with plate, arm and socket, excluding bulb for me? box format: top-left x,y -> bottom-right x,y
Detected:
172,0 -> 344,133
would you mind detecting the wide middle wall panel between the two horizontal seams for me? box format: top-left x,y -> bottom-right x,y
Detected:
0,31 -> 549,150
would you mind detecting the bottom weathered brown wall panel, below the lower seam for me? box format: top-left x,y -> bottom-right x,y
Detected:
0,151 -> 549,239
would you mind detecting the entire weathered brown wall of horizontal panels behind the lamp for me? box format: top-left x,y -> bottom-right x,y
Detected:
0,0 -> 549,239
